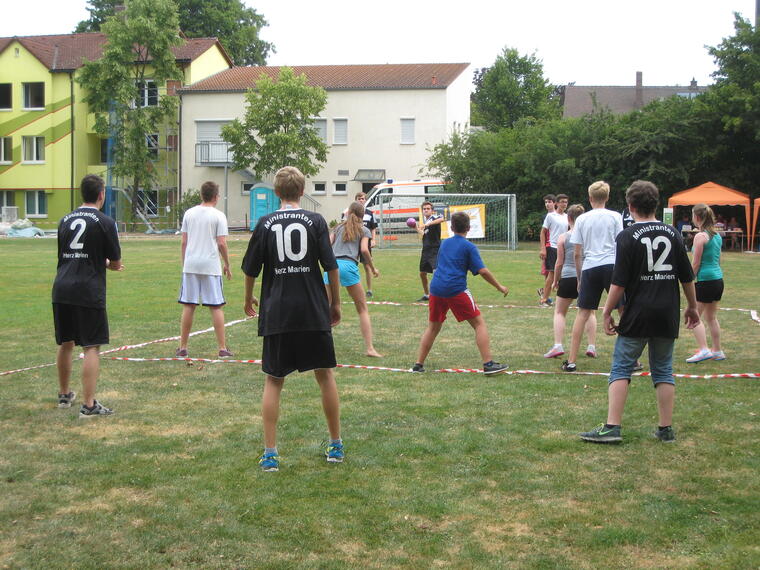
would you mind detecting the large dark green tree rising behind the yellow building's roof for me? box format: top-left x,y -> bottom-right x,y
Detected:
75,0 -> 274,65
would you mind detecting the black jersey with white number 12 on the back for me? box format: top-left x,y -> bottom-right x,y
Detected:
612,222 -> 694,338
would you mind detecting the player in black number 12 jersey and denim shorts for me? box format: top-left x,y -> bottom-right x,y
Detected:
580,180 -> 699,443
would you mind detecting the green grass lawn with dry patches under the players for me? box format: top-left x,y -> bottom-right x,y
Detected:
0,234 -> 760,568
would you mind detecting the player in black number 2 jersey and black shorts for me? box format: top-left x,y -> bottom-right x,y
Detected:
53,174 -> 124,418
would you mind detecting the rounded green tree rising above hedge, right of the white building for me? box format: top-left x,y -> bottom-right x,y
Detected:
471,48 -> 561,131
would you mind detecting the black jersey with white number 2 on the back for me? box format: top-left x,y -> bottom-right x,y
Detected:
53,207 -> 121,309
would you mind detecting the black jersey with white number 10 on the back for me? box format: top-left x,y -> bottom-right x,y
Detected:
242,208 -> 338,336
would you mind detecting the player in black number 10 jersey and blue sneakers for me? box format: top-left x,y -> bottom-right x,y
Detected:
242,166 -> 343,471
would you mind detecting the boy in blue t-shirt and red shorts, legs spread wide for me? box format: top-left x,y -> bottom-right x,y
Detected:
412,212 -> 509,375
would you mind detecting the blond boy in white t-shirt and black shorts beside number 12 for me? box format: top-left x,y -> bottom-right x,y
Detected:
562,180 -> 623,372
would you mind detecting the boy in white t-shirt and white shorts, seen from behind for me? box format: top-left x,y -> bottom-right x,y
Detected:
176,182 -> 232,358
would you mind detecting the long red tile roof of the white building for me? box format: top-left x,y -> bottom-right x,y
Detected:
180,63 -> 469,93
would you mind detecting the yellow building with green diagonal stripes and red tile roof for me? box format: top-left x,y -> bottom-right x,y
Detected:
0,33 -> 232,229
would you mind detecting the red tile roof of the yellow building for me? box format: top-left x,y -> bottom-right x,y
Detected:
0,33 -> 232,71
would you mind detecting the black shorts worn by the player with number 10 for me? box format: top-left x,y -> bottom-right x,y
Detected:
261,331 -> 336,378
